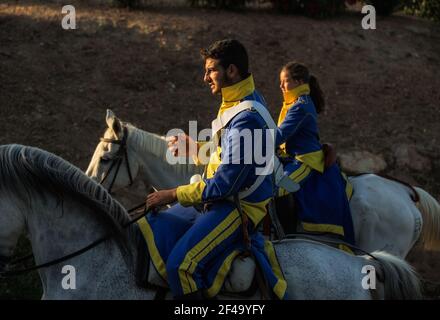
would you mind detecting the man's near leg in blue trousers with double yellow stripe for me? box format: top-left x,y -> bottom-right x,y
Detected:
166,202 -> 243,296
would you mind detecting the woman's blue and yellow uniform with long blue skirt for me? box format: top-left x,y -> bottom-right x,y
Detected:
275,84 -> 355,244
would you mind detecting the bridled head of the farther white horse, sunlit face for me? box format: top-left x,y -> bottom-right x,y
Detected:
86,110 -> 139,191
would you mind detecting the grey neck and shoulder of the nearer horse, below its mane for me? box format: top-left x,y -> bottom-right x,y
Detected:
26,192 -> 152,299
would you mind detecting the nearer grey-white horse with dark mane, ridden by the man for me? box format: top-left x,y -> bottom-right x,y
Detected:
0,145 -> 420,299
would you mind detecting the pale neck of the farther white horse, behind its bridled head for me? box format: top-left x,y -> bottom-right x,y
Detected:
128,126 -> 196,189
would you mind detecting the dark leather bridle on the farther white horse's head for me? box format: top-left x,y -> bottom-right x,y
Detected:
99,127 -> 133,194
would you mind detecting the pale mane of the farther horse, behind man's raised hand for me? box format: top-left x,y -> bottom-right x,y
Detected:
123,122 -> 202,176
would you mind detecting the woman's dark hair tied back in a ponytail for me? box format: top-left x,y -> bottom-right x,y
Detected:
281,61 -> 325,113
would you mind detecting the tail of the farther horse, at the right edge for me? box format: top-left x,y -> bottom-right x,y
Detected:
414,187 -> 440,250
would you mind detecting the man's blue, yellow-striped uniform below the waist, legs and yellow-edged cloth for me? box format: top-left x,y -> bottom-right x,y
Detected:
143,201 -> 286,299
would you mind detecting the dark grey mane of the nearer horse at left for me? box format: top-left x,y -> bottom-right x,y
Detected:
0,144 -> 130,235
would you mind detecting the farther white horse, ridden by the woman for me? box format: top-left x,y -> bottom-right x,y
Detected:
86,110 -> 440,258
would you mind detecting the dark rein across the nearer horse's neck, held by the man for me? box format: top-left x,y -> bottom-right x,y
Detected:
0,203 -> 151,279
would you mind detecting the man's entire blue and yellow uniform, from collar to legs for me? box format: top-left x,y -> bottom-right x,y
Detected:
141,75 -> 287,299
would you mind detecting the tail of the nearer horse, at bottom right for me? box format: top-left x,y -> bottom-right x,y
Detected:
372,251 -> 423,300
